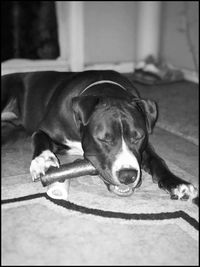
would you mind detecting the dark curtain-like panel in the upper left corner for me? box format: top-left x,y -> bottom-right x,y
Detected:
1,1 -> 59,61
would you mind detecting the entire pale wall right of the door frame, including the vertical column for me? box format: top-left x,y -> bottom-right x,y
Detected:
83,1 -> 199,73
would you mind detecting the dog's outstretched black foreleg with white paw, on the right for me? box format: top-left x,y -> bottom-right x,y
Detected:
142,144 -> 198,200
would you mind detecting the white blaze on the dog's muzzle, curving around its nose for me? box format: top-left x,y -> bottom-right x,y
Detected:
112,138 -> 141,186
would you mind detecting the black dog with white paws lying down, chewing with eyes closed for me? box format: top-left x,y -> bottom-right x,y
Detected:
2,71 -> 198,200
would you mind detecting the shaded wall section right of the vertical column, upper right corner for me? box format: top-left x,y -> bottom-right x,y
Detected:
161,1 -> 199,70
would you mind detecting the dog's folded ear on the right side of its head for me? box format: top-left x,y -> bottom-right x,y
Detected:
138,99 -> 158,133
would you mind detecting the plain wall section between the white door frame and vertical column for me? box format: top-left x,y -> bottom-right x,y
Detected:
84,1 -> 137,64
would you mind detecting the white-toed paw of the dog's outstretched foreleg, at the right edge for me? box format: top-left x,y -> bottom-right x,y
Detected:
171,184 -> 198,200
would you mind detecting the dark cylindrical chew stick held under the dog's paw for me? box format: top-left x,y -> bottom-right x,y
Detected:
40,159 -> 98,186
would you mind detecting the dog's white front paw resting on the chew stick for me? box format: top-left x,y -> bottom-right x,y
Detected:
30,150 -> 60,181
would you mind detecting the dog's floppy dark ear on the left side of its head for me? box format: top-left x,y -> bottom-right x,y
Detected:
72,96 -> 99,127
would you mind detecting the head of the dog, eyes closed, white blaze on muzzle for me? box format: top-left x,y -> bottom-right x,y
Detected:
72,96 -> 157,196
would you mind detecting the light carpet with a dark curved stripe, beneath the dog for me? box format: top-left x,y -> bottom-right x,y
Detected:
1,138 -> 199,266
